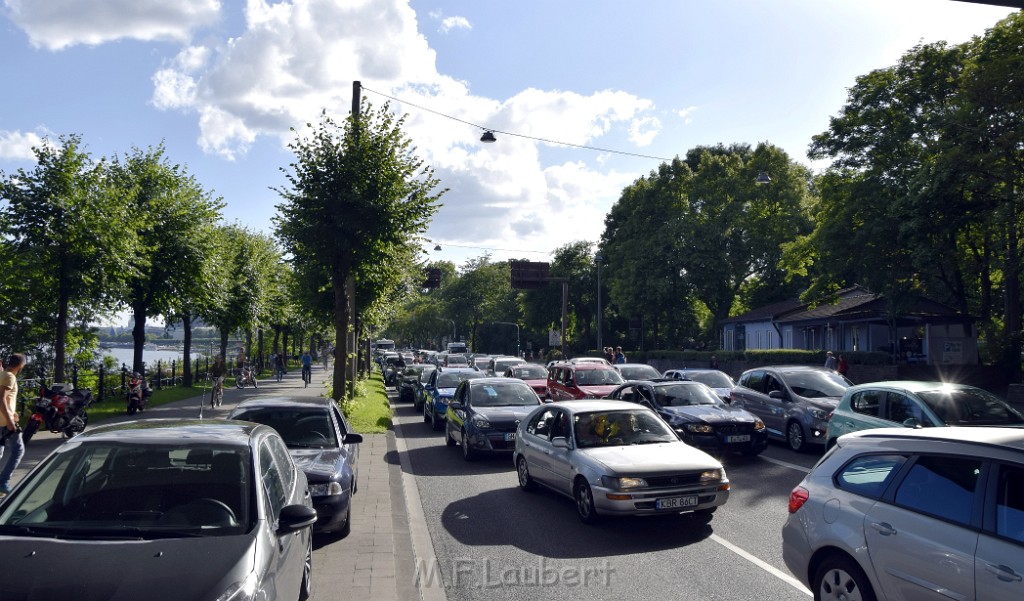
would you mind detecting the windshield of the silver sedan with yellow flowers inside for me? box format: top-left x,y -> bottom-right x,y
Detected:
573,410 -> 678,448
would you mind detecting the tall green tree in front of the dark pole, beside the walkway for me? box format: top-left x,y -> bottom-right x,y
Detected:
274,101 -> 443,398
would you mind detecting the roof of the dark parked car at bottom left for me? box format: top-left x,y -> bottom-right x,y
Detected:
81,418 -> 262,446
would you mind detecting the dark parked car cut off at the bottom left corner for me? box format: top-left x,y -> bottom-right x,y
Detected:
0,419 -> 316,601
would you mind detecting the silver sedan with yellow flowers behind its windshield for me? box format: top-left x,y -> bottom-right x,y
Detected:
513,400 -> 729,523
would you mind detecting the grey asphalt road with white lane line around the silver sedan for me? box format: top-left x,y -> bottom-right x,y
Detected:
395,395 -> 819,601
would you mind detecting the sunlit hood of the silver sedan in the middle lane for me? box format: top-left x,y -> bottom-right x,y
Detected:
577,442 -> 722,476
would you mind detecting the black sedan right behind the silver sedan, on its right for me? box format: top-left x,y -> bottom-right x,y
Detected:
608,381 -> 768,456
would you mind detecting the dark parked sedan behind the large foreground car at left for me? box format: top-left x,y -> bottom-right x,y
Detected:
228,396 -> 362,536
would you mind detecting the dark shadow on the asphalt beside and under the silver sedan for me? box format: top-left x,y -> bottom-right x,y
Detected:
441,488 -> 713,559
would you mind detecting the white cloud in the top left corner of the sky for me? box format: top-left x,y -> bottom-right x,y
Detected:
5,0 -> 220,50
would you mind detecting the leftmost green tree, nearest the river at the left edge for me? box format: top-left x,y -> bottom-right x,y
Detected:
0,135 -> 136,380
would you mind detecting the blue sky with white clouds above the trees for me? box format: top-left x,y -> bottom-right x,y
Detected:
0,0 -> 1014,264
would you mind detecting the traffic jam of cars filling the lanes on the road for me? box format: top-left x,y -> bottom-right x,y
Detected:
395,359 -> 1024,601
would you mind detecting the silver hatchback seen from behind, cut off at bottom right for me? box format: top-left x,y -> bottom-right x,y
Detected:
782,427 -> 1024,601
